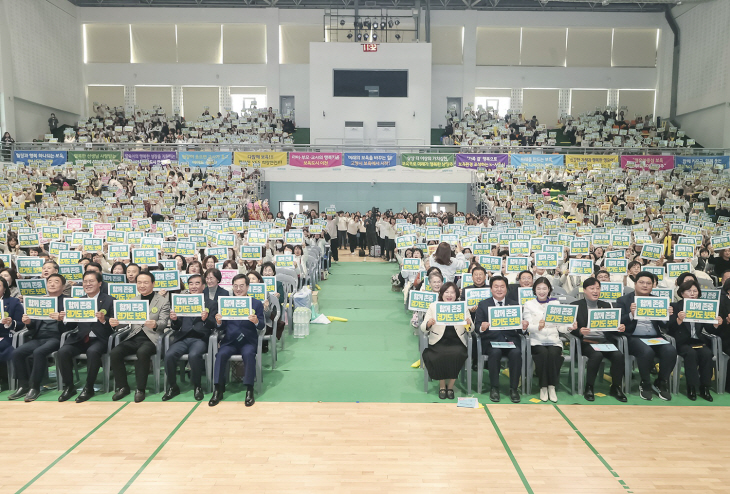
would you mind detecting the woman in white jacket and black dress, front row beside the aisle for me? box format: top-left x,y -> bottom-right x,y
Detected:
421,282 -> 472,400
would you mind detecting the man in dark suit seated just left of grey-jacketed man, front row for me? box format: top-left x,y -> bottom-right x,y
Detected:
57,271 -> 114,403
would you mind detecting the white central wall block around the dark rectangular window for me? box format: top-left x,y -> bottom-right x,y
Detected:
309,43 -> 431,145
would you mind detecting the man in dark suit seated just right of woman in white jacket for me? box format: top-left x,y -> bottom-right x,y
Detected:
572,277 -> 626,402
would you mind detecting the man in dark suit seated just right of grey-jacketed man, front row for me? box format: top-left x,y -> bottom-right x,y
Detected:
162,269 -> 215,401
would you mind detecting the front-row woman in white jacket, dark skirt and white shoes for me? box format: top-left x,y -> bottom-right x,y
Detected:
523,277 -> 577,403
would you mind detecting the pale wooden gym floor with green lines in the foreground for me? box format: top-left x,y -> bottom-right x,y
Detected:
0,402 -> 730,494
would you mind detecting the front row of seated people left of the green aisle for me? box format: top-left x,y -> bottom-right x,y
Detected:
0,268 -> 264,406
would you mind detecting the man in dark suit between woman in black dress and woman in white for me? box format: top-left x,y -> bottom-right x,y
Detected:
474,276 -> 528,403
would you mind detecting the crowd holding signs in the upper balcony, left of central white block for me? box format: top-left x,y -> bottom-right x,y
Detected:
52,103 -> 295,144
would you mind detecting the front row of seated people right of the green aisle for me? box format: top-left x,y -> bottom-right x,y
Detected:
413,265 -> 727,403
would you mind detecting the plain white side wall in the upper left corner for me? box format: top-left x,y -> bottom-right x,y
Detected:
0,0 -> 84,142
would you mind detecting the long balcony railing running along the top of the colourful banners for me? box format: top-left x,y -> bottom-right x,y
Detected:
2,142 -> 730,156
